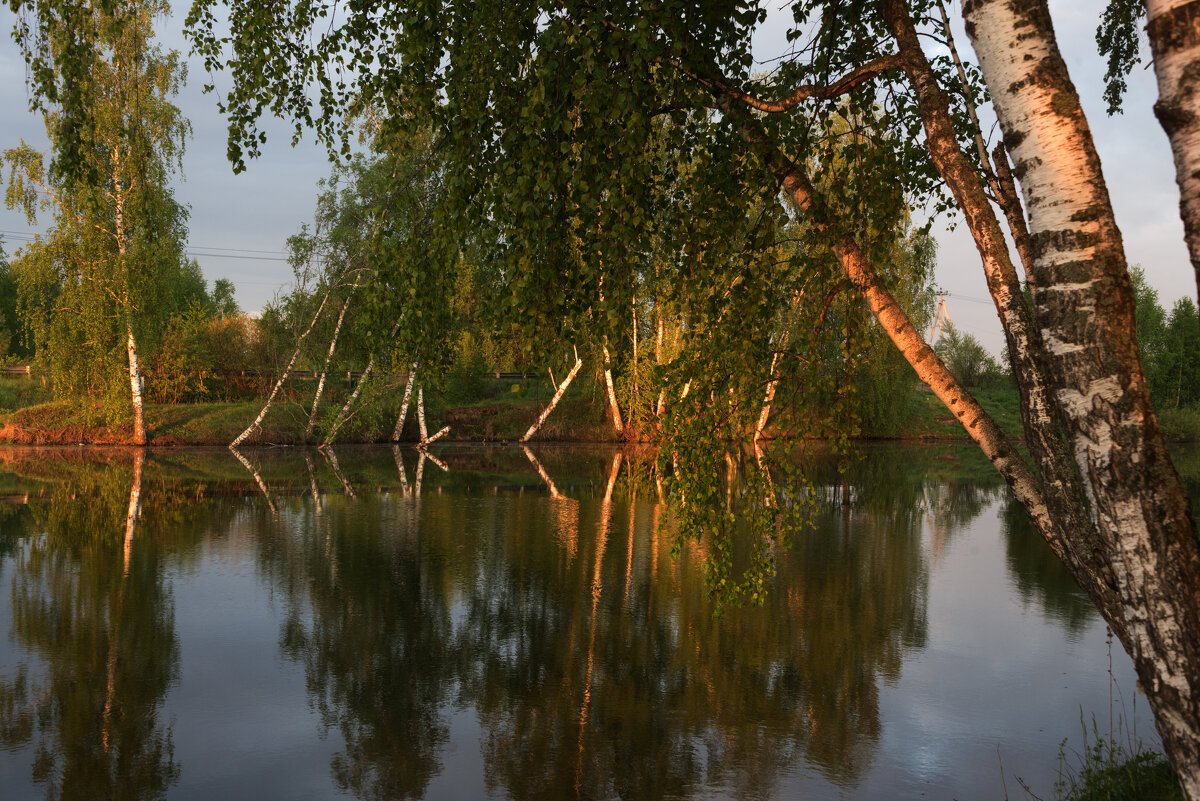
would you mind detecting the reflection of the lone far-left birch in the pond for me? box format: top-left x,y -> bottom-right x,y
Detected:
0,451 -> 220,801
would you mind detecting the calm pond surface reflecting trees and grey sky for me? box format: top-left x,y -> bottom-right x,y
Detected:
0,446 -> 1154,801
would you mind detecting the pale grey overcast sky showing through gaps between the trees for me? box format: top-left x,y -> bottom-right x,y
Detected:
0,0 -> 1196,354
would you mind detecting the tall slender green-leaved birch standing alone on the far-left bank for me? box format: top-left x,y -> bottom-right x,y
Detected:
4,1 -> 190,445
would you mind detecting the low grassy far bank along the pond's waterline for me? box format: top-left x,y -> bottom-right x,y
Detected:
0,380 -> 1200,446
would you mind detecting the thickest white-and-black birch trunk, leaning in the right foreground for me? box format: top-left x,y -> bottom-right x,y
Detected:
964,0 -> 1200,801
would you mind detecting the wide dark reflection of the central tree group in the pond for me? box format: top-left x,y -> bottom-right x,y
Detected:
266,450 -> 1012,799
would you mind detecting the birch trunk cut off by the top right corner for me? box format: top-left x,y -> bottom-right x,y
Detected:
1146,0 -> 1200,297
